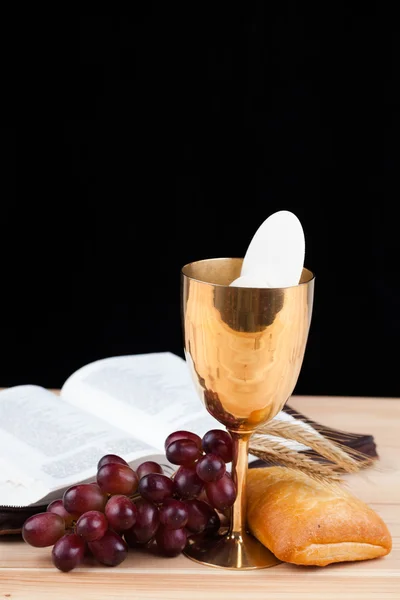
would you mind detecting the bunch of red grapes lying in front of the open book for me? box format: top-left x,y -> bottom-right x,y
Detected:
22,429 -> 236,571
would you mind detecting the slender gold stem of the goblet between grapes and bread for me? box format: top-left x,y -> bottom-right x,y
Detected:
228,431 -> 251,539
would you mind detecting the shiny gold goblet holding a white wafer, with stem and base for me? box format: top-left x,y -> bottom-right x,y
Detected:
181,258 -> 314,569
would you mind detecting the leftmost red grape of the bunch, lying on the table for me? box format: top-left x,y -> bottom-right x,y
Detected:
22,512 -> 65,548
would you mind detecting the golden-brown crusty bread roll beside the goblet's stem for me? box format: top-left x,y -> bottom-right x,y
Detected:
247,467 -> 392,567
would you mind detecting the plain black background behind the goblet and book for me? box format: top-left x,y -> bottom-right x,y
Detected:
0,9 -> 400,396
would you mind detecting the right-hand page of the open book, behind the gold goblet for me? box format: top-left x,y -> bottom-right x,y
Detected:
61,352 -> 306,460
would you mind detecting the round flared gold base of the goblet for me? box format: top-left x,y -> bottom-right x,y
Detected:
183,533 -> 282,571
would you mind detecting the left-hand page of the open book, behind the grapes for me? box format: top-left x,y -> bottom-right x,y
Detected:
0,385 -> 159,506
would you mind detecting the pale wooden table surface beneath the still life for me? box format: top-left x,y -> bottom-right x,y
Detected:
0,396 -> 400,600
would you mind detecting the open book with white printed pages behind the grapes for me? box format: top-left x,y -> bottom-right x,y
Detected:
0,352 -> 310,507
